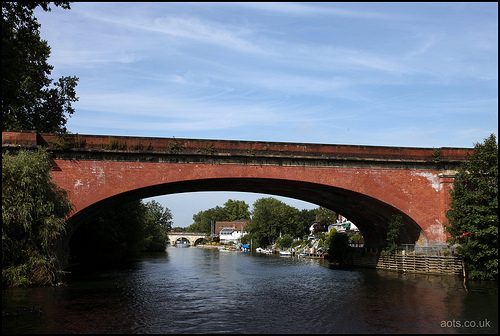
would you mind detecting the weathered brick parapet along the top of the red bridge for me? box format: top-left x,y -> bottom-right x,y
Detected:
2,131 -> 472,163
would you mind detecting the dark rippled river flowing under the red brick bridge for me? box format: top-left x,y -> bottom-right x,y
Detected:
2,247 -> 498,334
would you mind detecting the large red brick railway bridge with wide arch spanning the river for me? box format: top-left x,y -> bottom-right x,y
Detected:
2,131 -> 472,247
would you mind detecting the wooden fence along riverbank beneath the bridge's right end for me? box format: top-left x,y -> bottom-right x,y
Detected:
344,249 -> 463,275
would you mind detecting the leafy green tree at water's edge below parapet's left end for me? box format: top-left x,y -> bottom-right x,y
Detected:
2,149 -> 73,286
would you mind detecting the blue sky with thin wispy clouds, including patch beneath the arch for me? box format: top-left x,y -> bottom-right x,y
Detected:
35,2 -> 498,226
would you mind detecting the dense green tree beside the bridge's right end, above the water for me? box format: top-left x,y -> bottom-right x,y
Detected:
444,134 -> 498,279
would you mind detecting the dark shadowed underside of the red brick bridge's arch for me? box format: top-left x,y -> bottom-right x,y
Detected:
69,178 -> 422,247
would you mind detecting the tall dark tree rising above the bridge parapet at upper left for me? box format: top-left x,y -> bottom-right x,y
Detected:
2,1 -> 78,133
